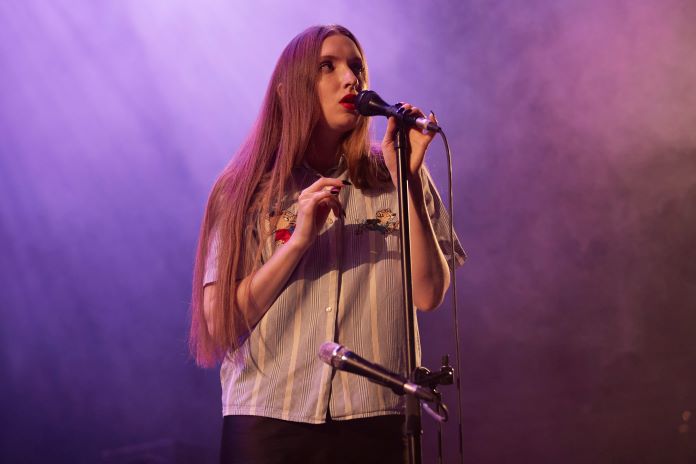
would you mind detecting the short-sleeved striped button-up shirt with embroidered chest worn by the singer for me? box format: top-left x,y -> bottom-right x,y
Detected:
205,162 -> 465,424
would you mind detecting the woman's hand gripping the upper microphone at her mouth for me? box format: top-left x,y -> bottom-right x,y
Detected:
382,103 -> 437,186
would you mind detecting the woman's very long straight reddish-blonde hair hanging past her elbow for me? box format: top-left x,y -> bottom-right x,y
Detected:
189,25 -> 389,367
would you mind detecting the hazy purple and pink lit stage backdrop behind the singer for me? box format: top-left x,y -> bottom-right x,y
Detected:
0,0 -> 696,464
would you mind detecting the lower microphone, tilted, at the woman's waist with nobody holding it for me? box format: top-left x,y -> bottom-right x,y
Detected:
319,342 -> 439,402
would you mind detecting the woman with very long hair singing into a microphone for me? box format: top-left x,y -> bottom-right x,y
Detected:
190,25 -> 462,463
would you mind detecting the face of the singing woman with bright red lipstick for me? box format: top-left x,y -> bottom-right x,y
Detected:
317,34 -> 363,134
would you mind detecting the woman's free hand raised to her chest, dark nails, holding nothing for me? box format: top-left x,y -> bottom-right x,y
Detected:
287,177 -> 343,250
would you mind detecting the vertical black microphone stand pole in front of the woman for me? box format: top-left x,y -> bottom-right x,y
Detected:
394,123 -> 423,464
